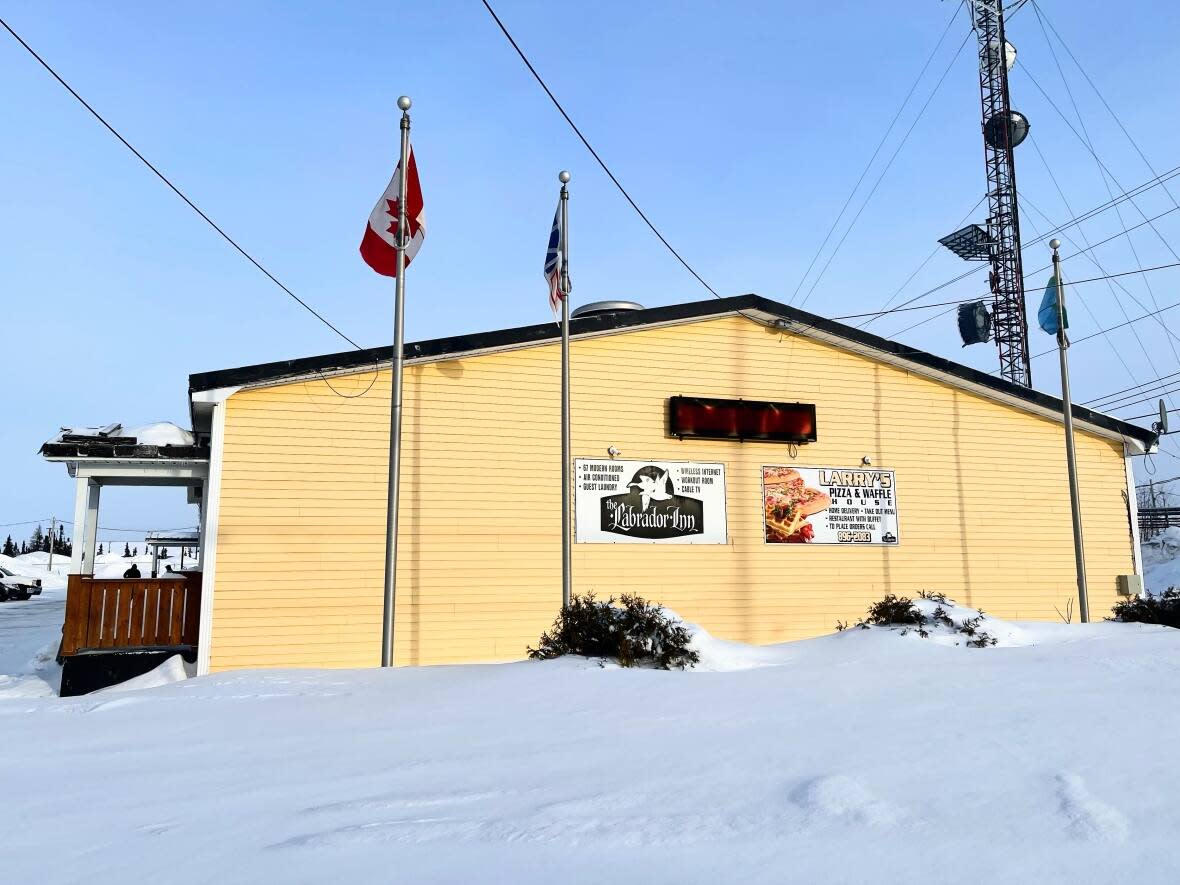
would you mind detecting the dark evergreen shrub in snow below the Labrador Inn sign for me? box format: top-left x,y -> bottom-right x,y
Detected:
529,592 -> 700,670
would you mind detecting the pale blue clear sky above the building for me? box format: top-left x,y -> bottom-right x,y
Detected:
0,0 -> 1180,536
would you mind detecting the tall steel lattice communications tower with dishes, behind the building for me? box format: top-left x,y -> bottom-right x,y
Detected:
938,0 -> 1033,387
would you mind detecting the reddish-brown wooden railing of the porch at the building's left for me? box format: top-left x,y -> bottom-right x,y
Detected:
61,572 -> 201,657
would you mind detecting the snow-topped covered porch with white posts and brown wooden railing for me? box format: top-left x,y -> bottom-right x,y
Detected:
41,424 -> 209,665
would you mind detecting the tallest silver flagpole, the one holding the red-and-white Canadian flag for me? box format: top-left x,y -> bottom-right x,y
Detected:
381,96 -> 412,667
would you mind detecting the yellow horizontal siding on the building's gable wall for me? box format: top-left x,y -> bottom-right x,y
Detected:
211,317 -> 1133,669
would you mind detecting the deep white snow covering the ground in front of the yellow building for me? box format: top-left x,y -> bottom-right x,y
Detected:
0,554 -> 1180,885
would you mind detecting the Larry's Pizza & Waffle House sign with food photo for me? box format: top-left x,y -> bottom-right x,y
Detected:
762,466 -> 899,546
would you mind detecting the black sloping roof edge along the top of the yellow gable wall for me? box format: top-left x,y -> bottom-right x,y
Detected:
189,295 -> 1158,448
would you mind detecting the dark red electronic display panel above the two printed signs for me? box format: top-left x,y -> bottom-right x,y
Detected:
668,396 -> 817,443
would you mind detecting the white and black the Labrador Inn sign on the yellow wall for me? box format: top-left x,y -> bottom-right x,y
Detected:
573,458 -> 727,544
